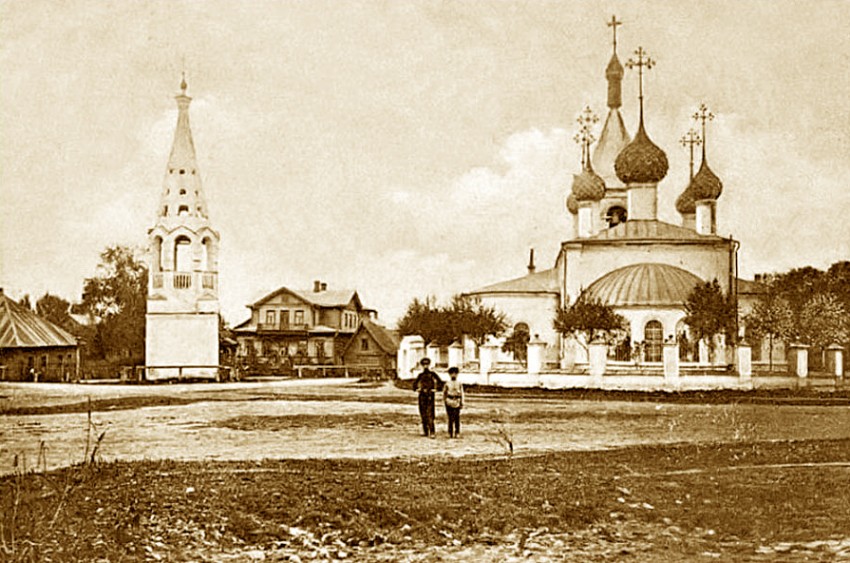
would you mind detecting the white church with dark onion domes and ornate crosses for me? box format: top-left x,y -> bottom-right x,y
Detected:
466,18 -> 739,367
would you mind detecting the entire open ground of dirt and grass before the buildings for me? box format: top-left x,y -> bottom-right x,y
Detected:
0,381 -> 850,561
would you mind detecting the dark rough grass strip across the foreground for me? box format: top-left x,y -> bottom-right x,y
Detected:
0,440 -> 850,561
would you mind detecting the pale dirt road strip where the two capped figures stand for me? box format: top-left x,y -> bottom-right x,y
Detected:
0,379 -> 850,474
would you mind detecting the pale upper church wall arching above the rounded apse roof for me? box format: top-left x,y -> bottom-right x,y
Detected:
559,242 -> 729,302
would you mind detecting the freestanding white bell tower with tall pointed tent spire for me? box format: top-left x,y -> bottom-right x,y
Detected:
145,78 -> 219,380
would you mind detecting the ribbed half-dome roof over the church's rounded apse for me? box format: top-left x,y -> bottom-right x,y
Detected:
581,263 -> 702,307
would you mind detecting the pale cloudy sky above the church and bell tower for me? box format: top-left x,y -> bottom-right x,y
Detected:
0,0 -> 850,326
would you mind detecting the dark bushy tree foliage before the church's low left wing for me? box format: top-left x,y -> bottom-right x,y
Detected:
398,295 -> 507,346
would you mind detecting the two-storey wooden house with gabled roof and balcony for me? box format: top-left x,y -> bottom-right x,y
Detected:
233,281 -> 374,373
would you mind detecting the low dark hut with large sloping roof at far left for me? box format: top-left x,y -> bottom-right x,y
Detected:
0,288 -> 80,381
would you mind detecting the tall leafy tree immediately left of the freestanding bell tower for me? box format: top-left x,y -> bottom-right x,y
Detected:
81,246 -> 148,359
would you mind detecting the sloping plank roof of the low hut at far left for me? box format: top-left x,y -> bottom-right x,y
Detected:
0,289 -> 77,348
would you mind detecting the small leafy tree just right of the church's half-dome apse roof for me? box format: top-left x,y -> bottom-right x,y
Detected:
684,279 -> 738,350
